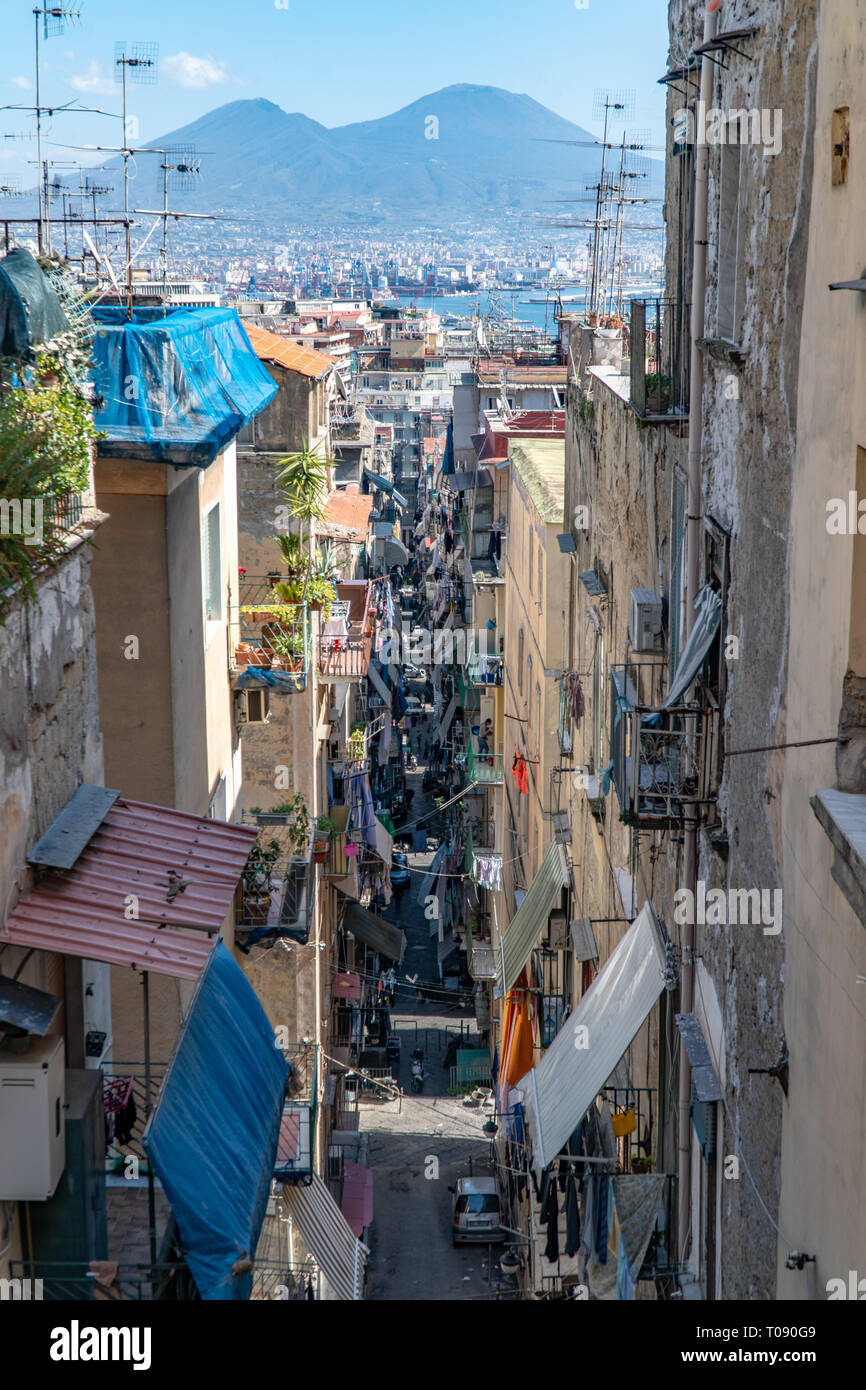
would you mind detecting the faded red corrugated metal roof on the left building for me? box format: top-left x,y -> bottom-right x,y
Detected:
0,798 -> 257,980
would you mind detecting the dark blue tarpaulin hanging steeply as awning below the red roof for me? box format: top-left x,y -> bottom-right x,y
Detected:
143,941 -> 289,1300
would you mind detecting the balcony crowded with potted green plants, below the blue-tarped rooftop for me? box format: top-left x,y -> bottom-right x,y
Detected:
232,578 -> 311,692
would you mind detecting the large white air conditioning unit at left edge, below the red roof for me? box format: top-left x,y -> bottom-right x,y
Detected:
0,1037 -> 67,1202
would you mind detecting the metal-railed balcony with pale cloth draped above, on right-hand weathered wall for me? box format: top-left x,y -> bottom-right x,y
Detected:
610,663 -> 719,830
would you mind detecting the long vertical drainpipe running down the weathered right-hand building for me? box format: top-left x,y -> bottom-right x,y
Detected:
677,0 -> 721,1264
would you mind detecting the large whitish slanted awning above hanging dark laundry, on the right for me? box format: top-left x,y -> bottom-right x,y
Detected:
521,888 -> 664,1173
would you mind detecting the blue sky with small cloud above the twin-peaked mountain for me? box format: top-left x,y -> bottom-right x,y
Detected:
0,0 -> 667,182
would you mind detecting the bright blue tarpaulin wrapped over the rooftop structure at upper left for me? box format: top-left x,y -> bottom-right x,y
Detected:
93,307 -> 277,467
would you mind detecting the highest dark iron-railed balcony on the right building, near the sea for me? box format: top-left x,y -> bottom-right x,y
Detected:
628,299 -> 688,424
